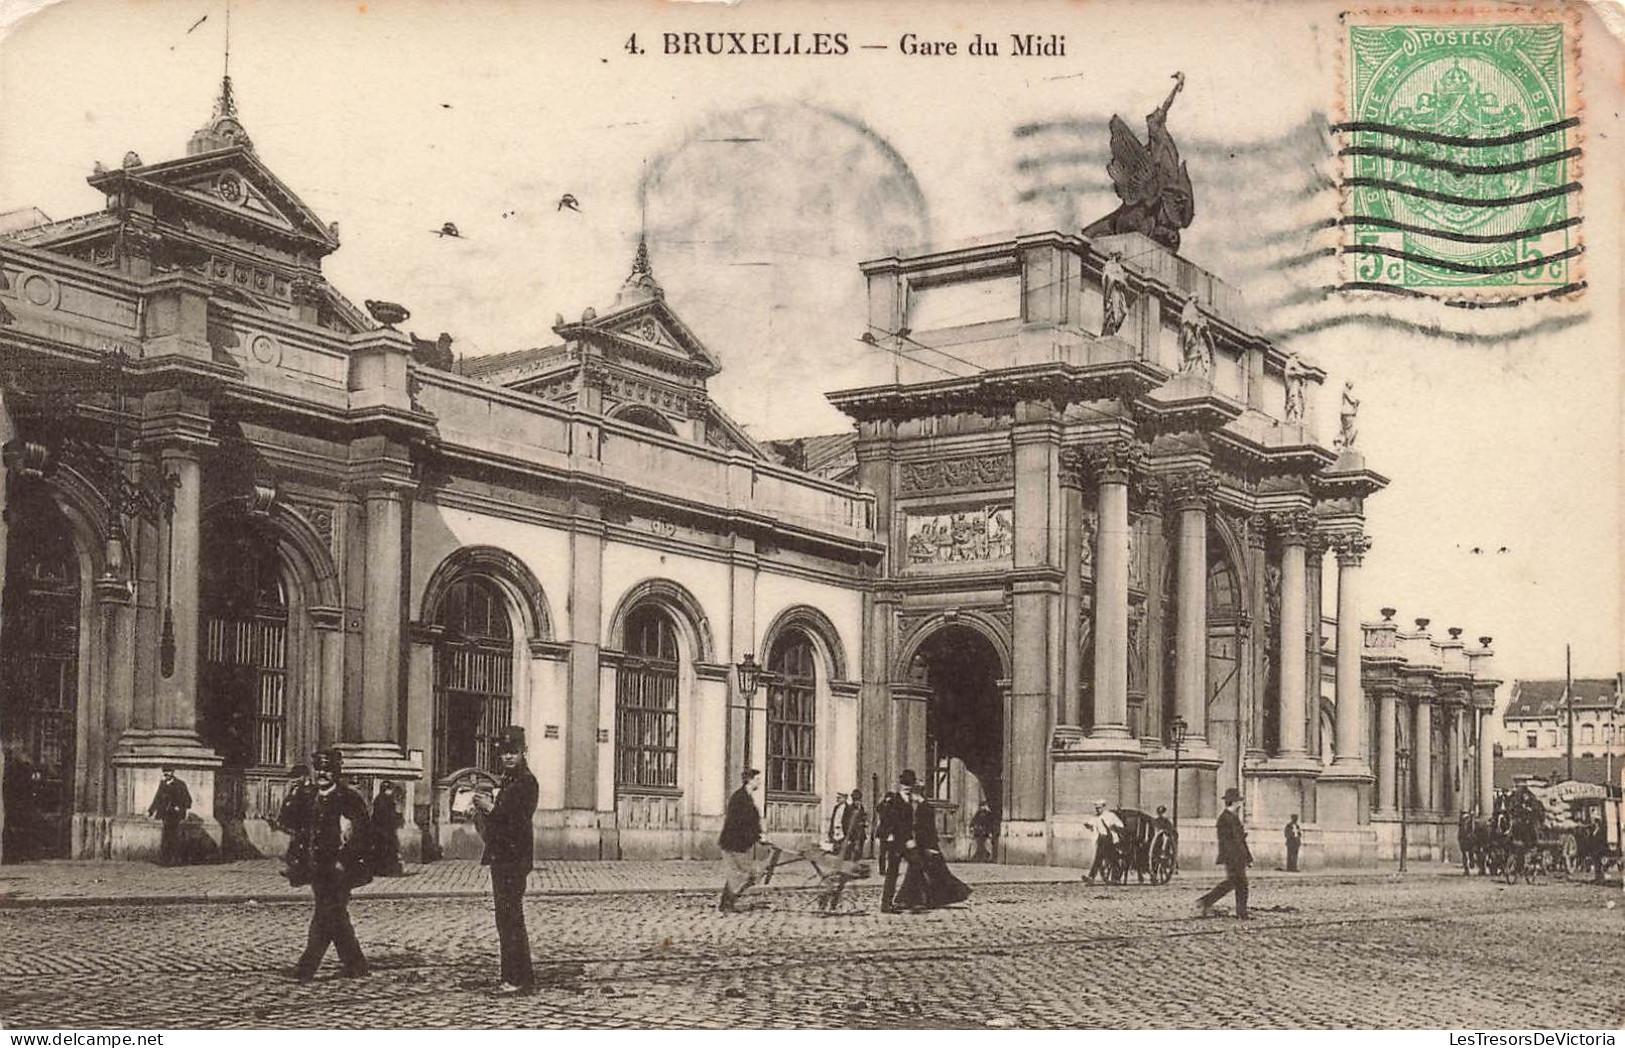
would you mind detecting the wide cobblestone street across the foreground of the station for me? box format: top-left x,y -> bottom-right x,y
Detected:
0,864 -> 1625,1029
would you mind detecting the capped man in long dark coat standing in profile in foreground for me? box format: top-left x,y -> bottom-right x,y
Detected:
475,728 -> 538,996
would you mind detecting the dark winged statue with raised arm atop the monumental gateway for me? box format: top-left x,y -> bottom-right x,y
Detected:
1084,73 -> 1196,252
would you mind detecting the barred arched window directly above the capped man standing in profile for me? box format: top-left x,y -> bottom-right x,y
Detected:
434,575 -> 514,775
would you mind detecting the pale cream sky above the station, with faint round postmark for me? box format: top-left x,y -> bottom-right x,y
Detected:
0,0 -> 1625,679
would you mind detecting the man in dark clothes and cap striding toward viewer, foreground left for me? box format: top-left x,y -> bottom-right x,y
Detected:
284,749 -> 372,983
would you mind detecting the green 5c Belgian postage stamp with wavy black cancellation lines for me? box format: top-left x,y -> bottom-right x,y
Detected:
1337,8 -> 1584,304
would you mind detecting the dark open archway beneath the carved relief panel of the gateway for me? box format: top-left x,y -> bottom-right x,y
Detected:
908,626 -> 1006,840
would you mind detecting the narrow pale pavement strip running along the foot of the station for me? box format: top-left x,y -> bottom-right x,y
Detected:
0,868 -> 1459,910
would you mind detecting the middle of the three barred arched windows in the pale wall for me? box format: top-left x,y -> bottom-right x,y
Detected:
614,604 -> 678,790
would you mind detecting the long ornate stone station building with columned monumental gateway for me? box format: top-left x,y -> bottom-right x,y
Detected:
0,81 -> 1495,864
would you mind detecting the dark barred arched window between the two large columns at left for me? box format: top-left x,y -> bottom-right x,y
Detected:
198,522 -> 288,769
